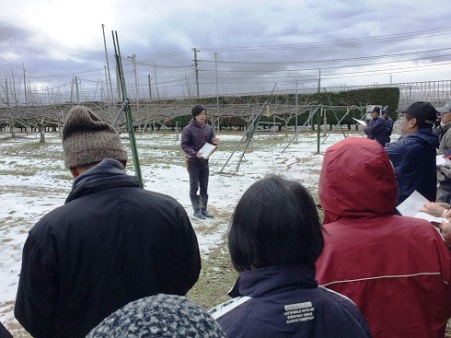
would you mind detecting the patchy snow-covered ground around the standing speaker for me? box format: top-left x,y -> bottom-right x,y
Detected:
0,131 -> 365,329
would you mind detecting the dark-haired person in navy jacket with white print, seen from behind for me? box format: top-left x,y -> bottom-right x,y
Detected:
210,175 -> 371,337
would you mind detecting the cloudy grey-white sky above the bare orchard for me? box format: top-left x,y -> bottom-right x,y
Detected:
0,0 -> 451,101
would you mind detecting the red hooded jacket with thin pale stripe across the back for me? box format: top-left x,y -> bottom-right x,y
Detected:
316,137 -> 451,338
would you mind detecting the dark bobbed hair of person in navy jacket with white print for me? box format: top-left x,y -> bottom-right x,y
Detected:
229,175 -> 324,272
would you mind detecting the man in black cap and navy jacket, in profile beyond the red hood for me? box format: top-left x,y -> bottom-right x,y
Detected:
385,101 -> 439,205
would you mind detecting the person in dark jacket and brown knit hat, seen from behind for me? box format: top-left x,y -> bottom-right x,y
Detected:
14,106 -> 201,338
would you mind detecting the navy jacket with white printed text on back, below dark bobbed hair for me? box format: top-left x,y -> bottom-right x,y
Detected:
209,266 -> 371,338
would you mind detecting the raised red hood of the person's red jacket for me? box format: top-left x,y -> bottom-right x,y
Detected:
319,137 -> 397,224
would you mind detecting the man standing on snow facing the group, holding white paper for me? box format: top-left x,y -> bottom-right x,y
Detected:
180,105 -> 219,219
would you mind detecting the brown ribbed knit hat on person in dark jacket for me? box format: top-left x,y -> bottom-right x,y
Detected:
63,106 -> 127,168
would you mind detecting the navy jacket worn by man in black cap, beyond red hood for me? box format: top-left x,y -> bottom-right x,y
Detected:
385,128 -> 439,205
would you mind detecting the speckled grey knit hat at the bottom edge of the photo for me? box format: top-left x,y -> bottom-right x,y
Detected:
86,294 -> 226,338
